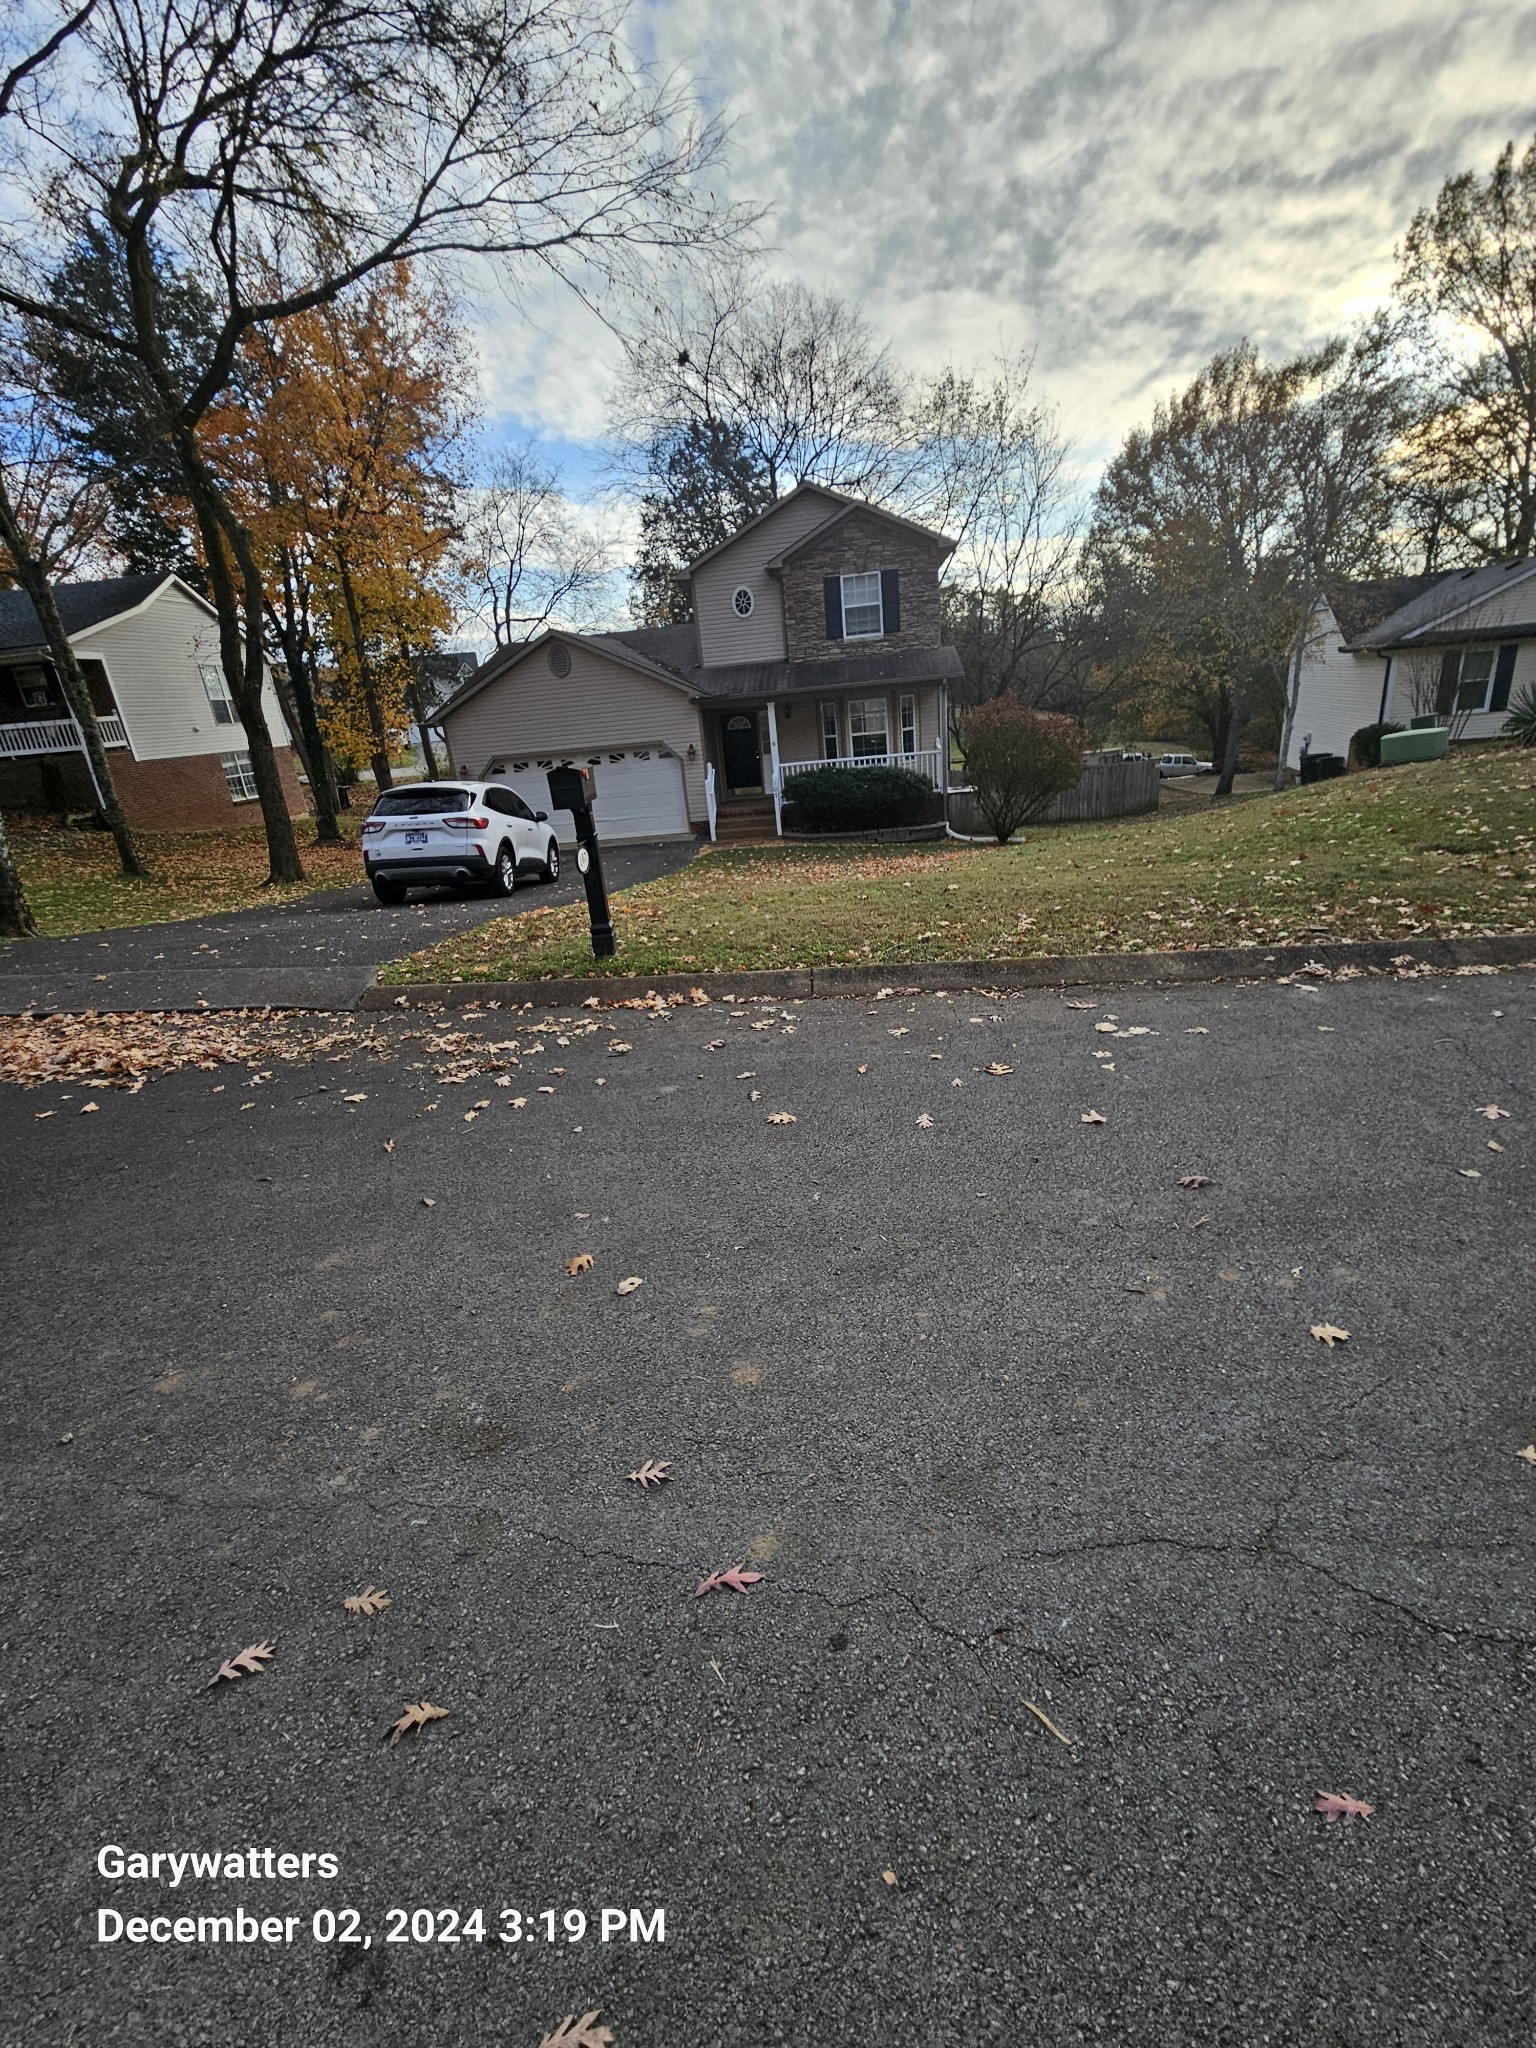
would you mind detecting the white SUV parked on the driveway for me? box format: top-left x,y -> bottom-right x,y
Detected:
362,782 -> 559,903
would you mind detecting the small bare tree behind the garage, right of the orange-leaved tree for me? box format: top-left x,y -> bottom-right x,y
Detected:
459,444 -> 612,647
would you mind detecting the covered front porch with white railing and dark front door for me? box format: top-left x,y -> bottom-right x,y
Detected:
698,682 -> 948,838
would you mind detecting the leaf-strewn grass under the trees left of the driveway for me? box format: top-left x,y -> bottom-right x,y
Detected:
6,813 -> 362,938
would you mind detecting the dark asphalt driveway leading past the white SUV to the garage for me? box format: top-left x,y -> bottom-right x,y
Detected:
0,842 -> 694,1016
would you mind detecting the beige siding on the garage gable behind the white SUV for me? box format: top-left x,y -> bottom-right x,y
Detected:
442,641 -> 707,823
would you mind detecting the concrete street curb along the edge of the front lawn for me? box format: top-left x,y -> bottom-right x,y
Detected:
358,932 -> 1536,1010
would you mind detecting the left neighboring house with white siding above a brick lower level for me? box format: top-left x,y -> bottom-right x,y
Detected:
0,573 -> 309,831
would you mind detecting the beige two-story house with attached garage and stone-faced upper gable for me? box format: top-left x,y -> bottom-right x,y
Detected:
434,483 -> 961,842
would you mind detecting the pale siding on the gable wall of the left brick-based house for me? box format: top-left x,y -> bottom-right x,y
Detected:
74,584 -> 293,762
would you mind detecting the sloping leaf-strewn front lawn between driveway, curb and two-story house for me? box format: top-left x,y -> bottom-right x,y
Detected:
383,750 -> 1536,981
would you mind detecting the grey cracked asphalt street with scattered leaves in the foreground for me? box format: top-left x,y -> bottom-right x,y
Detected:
0,966 -> 1536,2048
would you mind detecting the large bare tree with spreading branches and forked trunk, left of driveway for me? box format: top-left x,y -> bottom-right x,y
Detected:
0,0 -> 739,881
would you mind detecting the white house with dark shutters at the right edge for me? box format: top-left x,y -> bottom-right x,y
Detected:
1286,559 -> 1536,768
